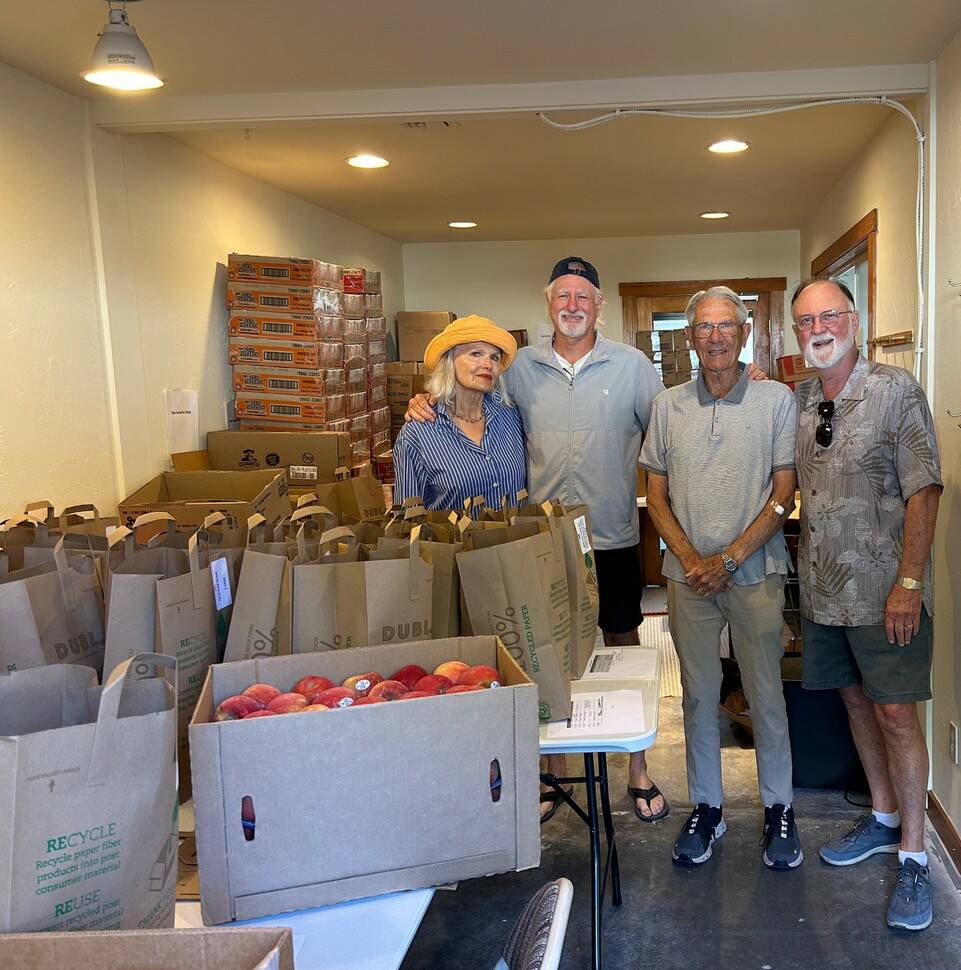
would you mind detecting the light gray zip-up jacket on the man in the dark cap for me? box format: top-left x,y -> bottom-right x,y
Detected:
504,333 -> 664,550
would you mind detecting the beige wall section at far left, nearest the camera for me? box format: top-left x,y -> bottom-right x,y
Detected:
0,64 -> 113,517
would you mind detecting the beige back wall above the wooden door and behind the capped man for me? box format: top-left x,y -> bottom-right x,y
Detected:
404,231 -> 800,339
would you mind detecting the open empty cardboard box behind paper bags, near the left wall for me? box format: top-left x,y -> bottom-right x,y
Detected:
117,470 -> 290,539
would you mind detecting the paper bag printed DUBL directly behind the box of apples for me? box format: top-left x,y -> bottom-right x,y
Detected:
291,526 -> 434,653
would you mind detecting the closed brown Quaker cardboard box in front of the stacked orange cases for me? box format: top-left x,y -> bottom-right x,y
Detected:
170,431 -> 350,488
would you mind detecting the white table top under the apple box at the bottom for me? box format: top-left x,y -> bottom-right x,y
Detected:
174,889 -> 434,970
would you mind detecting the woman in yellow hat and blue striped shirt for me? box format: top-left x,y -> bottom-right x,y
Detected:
394,316 -> 527,509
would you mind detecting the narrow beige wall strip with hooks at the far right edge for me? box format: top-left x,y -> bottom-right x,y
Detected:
931,34 -> 961,830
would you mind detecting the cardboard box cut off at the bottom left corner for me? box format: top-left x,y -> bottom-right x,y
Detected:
0,926 -> 294,970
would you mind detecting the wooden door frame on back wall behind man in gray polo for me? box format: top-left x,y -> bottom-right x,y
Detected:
618,276 -> 787,376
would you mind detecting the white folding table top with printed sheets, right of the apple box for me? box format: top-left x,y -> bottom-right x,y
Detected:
540,647 -> 661,754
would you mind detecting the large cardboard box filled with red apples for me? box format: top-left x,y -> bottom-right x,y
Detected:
190,636 -> 540,924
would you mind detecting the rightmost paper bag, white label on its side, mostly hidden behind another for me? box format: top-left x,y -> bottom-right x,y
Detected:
514,502 -> 600,678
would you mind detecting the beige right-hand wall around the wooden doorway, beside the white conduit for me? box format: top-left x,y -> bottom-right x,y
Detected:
801,106 -> 918,370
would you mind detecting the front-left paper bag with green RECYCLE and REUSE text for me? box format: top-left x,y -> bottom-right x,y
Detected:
0,654 -> 178,933
